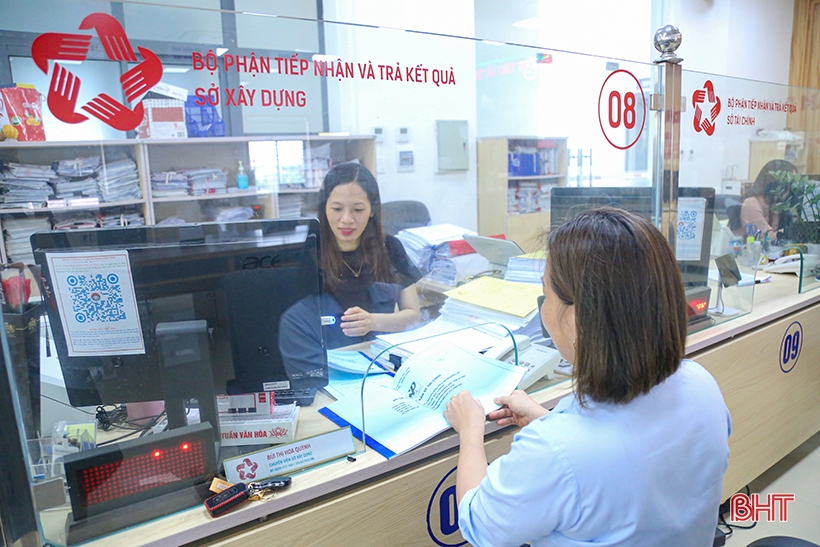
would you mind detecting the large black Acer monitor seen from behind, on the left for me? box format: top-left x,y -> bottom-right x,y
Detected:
31,219 -> 327,428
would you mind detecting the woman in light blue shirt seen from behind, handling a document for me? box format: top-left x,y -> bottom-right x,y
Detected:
444,208 -> 731,547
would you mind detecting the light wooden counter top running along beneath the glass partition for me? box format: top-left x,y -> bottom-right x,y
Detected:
40,275 -> 820,547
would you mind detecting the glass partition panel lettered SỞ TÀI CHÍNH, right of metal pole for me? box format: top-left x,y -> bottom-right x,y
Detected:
680,70 -> 820,300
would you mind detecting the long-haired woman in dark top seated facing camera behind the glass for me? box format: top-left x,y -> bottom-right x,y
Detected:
318,163 -> 421,347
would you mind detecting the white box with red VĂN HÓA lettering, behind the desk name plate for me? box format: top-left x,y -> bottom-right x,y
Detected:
219,403 -> 299,446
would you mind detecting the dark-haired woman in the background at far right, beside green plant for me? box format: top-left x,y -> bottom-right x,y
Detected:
729,156 -> 797,240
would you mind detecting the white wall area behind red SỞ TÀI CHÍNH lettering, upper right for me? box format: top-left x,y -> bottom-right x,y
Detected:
663,0 -> 794,192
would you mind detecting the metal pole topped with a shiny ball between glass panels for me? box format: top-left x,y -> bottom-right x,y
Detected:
653,25 -> 683,254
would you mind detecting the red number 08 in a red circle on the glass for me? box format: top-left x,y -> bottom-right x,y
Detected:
598,69 -> 646,150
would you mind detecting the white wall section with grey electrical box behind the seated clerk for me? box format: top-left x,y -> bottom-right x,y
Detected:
325,0 -> 477,229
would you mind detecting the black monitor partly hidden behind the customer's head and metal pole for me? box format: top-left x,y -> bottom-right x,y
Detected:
550,187 -> 715,289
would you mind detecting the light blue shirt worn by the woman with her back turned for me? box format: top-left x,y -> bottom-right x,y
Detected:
458,360 -> 731,547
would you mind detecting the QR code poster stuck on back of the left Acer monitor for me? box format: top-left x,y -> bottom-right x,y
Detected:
46,251 -> 145,357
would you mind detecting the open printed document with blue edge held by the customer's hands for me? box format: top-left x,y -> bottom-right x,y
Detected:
319,341 -> 526,459
